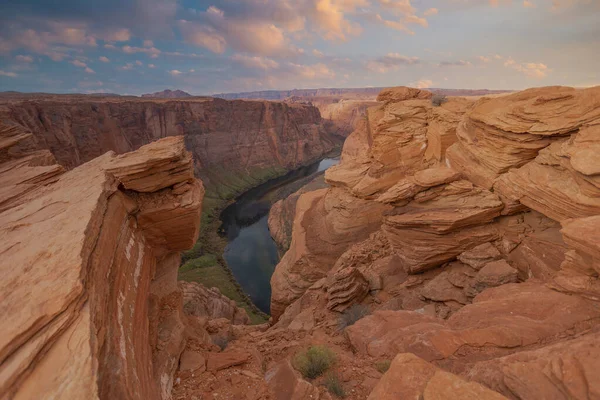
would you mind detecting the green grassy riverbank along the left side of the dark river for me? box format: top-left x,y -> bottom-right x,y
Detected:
178,148 -> 341,324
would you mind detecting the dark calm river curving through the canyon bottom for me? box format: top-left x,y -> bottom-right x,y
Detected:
220,158 -> 339,314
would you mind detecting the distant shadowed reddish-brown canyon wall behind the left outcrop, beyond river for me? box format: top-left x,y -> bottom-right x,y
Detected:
0,95 -> 343,198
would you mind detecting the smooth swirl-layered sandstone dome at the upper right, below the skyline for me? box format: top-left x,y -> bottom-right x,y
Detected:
448,87 -> 600,188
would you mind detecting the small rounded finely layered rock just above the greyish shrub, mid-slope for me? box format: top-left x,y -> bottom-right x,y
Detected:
327,268 -> 369,312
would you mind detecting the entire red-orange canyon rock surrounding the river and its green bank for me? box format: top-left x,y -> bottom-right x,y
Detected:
0,87 -> 600,400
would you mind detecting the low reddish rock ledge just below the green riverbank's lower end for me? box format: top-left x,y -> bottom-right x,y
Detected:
179,281 -> 250,325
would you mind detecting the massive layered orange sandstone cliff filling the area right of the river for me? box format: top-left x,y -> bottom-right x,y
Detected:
262,87 -> 600,400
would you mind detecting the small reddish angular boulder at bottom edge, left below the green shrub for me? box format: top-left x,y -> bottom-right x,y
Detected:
265,360 -> 320,400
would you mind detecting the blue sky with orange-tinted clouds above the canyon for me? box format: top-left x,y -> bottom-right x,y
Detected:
0,0 -> 600,95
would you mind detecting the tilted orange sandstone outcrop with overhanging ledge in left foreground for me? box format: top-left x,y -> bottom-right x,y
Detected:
0,134 -> 204,399
